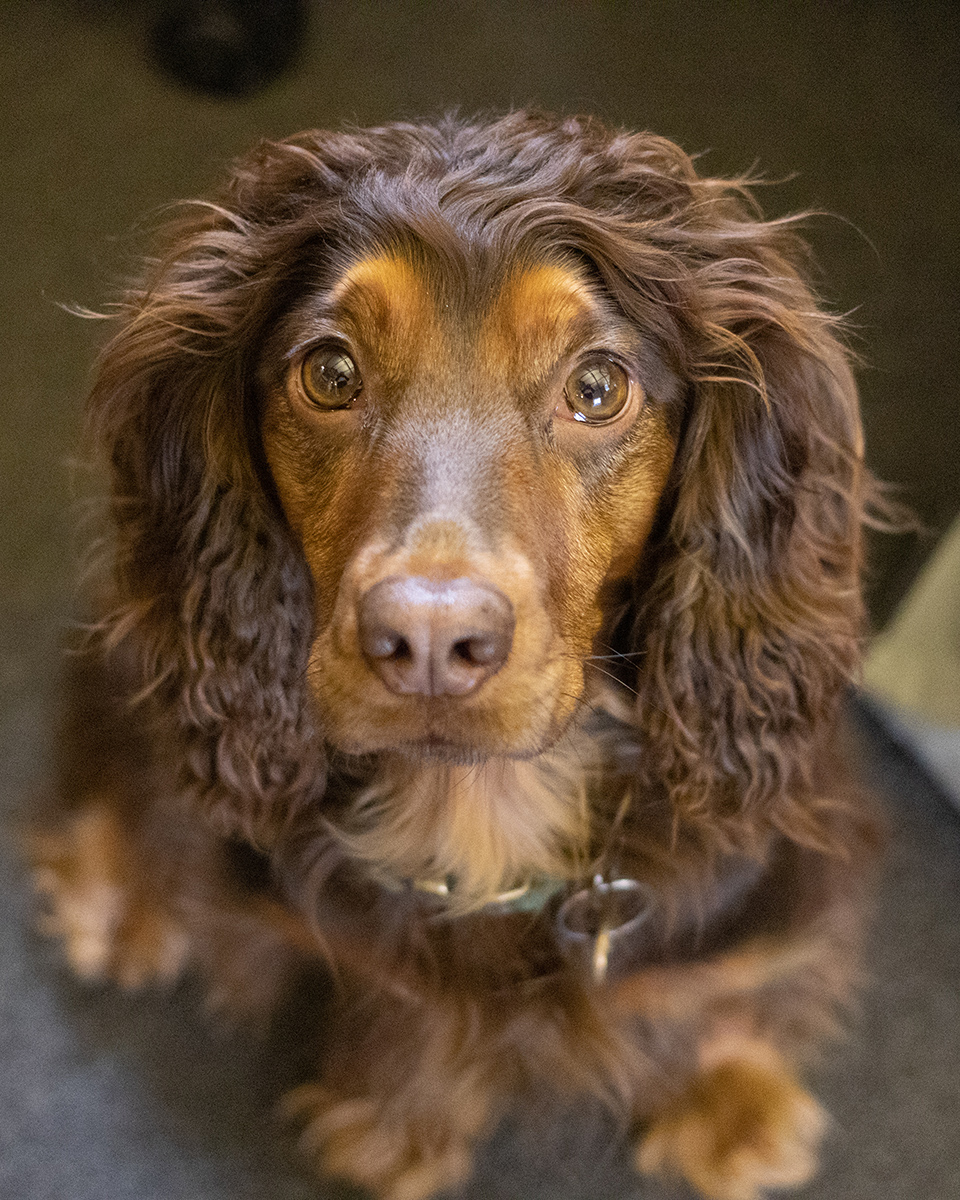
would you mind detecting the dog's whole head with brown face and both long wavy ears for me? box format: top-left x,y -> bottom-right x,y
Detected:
92,114 -> 862,838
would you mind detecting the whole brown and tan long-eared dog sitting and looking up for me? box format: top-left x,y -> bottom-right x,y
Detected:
31,112 -> 877,1200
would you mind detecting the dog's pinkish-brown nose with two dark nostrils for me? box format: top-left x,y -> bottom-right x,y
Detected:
359,575 -> 515,696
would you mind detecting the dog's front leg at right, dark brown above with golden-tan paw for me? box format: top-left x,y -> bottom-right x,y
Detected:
612,817 -> 872,1200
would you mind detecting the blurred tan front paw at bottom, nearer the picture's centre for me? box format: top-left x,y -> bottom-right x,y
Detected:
283,1084 -> 473,1200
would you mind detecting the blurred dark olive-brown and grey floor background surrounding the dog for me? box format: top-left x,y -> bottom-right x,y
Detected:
0,0 -> 960,1200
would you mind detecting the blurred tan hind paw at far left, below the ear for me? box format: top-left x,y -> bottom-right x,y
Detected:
29,806 -> 188,988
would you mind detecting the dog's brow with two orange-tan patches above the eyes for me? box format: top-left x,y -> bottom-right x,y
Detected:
329,252 -> 611,374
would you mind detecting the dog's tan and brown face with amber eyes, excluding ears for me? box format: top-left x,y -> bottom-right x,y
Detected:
262,246 -> 679,761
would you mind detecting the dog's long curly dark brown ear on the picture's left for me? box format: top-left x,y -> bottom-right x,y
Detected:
89,139 -> 372,844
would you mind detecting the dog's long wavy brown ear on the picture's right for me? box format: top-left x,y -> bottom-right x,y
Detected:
634,218 -> 869,848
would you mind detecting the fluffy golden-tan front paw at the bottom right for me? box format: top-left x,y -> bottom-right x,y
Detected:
637,1058 -> 827,1200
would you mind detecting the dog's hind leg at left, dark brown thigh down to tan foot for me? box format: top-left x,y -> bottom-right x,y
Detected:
26,652 -> 317,1020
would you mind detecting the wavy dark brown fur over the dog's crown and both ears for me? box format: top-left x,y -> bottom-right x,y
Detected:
91,114 -> 868,846
